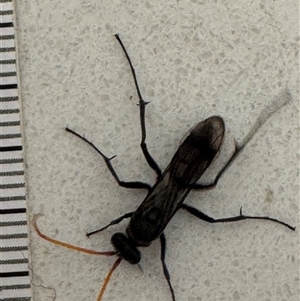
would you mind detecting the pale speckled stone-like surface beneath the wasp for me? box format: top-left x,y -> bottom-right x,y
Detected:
16,0 -> 299,301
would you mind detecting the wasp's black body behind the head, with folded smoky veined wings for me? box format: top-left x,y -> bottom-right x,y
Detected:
126,116 -> 225,246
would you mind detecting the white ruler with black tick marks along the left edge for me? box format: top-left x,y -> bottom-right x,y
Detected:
0,0 -> 31,301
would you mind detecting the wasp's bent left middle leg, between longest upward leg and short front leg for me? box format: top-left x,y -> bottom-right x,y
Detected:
66,128 -> 151,190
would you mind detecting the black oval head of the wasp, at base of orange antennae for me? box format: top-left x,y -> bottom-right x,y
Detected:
110,233 -> 141,264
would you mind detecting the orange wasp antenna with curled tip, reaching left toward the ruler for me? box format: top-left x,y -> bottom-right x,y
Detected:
32,214 -> 116,256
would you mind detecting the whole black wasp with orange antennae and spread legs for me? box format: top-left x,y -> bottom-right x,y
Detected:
33,35 -> 295,301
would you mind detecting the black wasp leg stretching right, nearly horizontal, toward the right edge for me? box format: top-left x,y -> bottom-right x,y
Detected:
181,204 -> 296,231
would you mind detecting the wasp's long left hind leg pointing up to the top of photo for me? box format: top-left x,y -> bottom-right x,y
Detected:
115,34 -> 161,177
